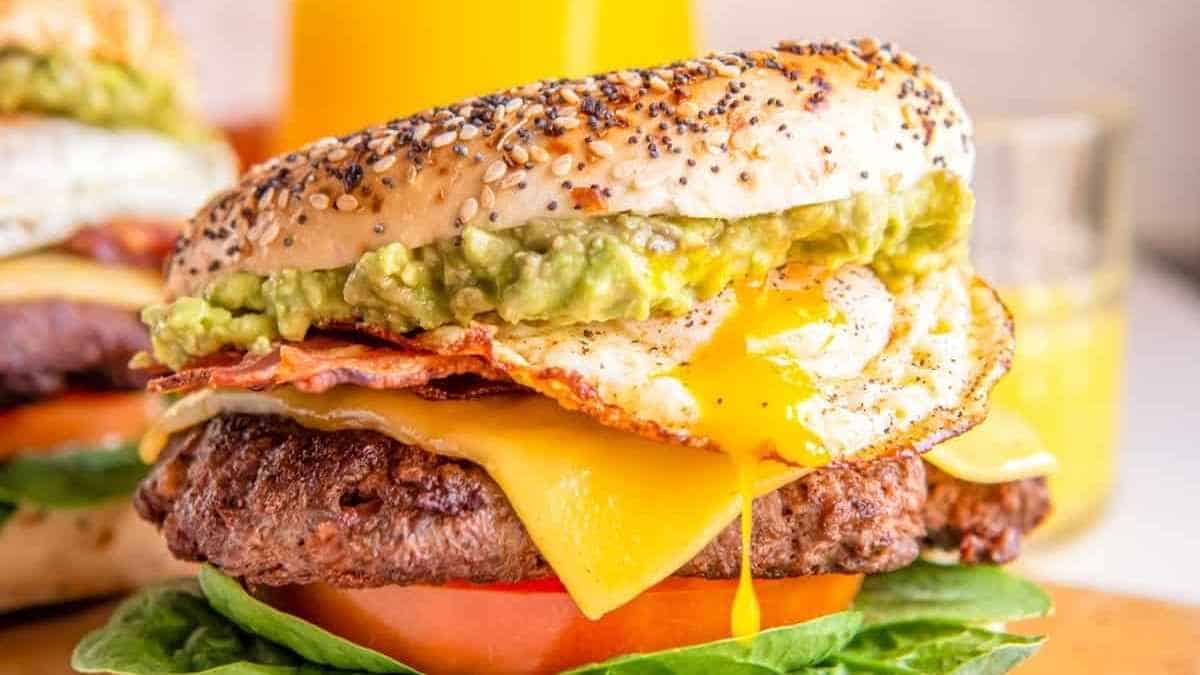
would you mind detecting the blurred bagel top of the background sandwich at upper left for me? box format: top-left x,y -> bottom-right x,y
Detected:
0,0 -> 193,100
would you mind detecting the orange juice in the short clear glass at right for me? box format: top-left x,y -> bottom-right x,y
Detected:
992,270 -> 1126,537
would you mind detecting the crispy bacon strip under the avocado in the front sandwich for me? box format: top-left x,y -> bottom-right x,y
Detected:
149,336 -> 516,399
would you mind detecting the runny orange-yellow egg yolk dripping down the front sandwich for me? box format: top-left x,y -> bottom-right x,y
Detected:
672,267 -> 838,639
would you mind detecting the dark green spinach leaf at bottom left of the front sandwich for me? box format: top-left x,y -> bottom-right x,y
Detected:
71,579 -> 357,675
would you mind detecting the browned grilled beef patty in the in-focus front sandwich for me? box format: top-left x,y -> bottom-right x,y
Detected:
136,414 -> 1048,587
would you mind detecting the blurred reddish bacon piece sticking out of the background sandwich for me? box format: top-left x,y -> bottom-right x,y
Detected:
61,220 -> 179,270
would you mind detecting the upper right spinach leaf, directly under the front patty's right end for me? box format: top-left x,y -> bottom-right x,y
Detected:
854,561 -> 1051,625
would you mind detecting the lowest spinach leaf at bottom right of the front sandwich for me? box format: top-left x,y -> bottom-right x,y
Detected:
796,621 -> 1045,675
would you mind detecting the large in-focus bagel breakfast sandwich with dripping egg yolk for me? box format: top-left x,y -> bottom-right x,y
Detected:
74,40 -> 1049,674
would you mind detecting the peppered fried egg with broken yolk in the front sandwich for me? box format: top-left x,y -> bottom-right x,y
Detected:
415,265 -> 1013,465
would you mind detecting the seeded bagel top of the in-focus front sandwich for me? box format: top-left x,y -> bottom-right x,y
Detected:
168,38 -> 973,297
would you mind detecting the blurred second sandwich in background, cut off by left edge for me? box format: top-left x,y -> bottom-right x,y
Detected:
0,0 -> 235,611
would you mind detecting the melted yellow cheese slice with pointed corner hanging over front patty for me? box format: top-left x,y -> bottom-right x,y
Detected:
142,387 -> 805,620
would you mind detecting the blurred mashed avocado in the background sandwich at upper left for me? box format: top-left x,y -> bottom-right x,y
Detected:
0,49 -> 206,139
